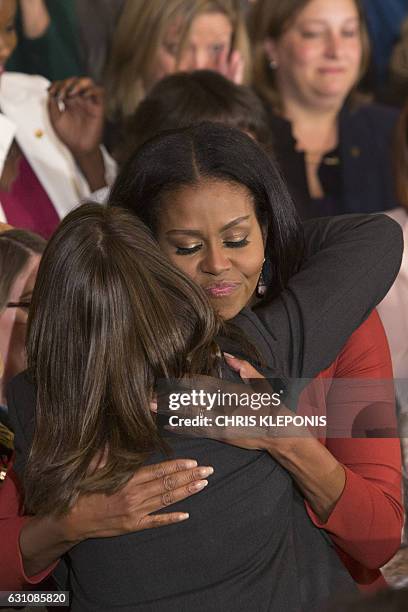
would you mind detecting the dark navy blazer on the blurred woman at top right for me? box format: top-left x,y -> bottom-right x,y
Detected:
270,104 -> 398,219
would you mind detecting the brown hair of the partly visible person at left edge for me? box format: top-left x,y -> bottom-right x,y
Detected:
0,229 -> 46,312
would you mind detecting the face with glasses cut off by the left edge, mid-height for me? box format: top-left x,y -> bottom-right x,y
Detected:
0,254 -> 41,400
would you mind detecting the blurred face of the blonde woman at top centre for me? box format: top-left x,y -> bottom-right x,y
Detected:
146,13 -> 232,88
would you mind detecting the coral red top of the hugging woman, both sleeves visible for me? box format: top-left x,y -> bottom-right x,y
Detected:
0,312 -> 403,590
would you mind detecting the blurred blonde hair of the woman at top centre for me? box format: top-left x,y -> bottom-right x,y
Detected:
106,0 -> 251,118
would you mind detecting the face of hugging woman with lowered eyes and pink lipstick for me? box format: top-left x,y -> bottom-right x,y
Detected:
157,179 -> 264,319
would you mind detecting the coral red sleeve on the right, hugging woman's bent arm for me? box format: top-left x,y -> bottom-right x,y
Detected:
306,312 -> 403,569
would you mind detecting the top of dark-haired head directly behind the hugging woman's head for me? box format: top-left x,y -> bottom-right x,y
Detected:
119,70 -> 271,162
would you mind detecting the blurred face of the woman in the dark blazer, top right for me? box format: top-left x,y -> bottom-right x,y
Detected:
265,0 -> 362,110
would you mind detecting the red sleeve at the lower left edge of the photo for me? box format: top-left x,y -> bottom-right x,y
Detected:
0,468 -> 56,591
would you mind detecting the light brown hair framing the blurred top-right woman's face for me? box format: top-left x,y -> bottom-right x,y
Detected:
248,0 -> 370,109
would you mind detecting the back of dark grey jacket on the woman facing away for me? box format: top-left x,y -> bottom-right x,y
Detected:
9,374 -> 357,612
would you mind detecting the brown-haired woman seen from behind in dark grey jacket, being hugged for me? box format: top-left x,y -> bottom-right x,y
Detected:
5,204 -> 353,612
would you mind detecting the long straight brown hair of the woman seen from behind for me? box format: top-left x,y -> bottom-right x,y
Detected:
26,204 -> 222,513
